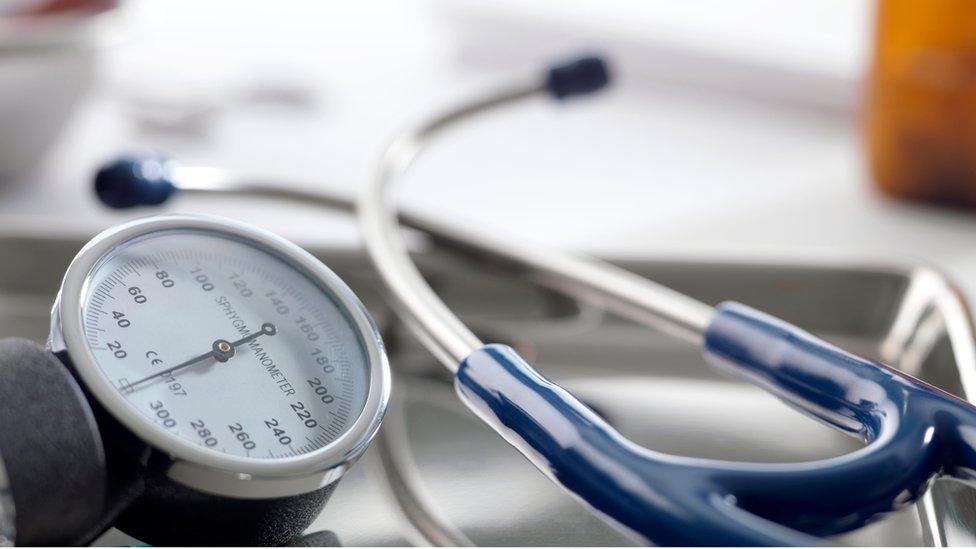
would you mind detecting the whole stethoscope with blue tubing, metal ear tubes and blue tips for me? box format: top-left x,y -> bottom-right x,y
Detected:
96,58 -> 976,545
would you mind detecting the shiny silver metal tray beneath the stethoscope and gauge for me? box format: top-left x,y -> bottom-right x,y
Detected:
0,232 -> 976,545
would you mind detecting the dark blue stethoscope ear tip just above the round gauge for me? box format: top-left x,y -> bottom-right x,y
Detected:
95,156 -> 176,209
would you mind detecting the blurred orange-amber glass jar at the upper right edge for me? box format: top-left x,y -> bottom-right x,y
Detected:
863,0 -> 976,208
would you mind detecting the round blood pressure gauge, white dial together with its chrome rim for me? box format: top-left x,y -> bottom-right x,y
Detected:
50,215 -> 390,499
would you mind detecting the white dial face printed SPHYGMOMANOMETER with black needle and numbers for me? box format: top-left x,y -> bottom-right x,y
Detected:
81,230 -> 370,459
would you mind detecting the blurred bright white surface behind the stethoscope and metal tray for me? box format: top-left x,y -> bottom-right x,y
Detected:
0,0 -> 976,292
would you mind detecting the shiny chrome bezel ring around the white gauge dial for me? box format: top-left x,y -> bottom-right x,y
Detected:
50,214 -> 390,498
